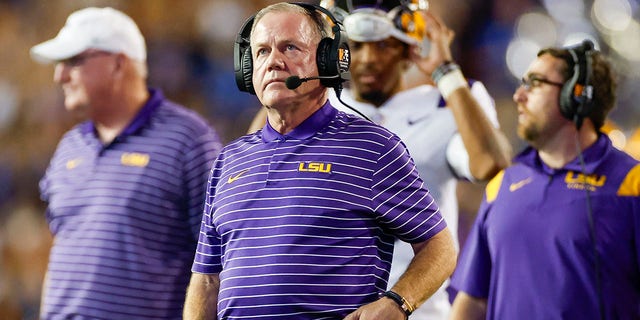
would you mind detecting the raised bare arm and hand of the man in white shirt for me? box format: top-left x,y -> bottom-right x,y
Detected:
411,12 -> 512,180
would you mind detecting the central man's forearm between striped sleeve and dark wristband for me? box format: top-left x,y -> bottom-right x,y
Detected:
391,229 -> 457,308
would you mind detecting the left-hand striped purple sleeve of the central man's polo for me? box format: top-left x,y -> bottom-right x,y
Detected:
191,158 -> 222,274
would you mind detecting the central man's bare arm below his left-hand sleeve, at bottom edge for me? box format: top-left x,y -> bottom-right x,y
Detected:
183,273 -> 220,320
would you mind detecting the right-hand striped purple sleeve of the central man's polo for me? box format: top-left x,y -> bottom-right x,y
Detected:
372,136 -> 447,243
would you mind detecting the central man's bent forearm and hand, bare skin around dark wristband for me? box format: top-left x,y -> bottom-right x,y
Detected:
345,228 -> 456,320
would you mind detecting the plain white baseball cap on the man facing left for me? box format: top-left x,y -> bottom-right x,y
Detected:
30,7 -> 147,63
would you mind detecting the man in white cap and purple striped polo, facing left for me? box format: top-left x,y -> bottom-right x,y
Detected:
31,8 -> 221,319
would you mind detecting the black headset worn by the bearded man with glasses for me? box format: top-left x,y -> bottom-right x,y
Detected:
560,40 -> 595,129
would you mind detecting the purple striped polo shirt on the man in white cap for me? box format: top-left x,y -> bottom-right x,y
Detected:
40,90 -> 221,319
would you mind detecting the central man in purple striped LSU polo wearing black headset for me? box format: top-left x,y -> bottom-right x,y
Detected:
184,3 -> 456,320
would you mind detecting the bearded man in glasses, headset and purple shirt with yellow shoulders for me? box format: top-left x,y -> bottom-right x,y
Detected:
452,41 -> 640,320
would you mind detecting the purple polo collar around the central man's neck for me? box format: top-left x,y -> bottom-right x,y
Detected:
262,99 -> 338,142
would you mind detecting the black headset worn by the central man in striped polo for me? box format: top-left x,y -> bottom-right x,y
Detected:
233,3 -> 351,94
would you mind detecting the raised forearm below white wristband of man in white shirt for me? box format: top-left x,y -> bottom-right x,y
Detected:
446,87 -> 512,180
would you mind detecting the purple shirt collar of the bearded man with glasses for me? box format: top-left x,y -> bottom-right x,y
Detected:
514,133 -> 613,174
